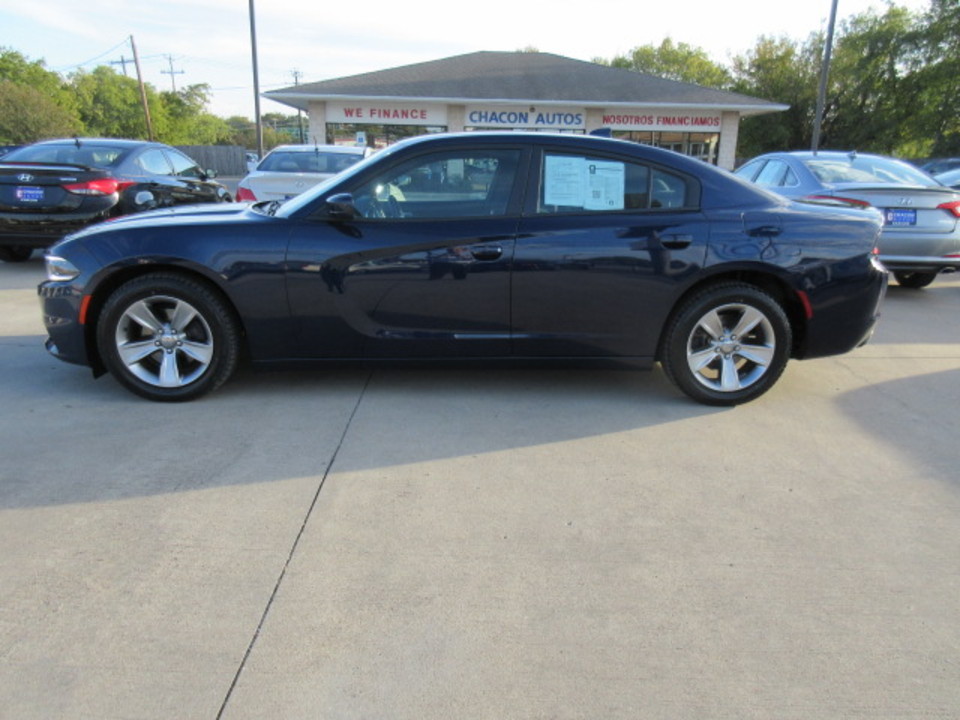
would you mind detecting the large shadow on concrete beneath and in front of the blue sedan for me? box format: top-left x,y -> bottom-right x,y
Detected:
0,336 -> 720,508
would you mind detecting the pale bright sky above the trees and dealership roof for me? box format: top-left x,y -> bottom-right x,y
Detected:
0,0 -> 929,118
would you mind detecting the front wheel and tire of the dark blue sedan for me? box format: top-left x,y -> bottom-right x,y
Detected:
97,273 -> 240,402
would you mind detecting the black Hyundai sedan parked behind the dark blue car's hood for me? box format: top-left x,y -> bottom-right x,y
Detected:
0,138 -> 232,262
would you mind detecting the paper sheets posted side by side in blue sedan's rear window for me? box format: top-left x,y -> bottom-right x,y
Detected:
543,155 -> 626,210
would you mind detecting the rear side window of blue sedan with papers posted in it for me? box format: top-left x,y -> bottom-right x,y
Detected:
537,152 -> 696,214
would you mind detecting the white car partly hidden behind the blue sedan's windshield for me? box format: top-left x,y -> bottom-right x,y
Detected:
237,145 -> 373,201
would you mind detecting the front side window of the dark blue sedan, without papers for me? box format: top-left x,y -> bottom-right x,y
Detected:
353,150 -> 520,219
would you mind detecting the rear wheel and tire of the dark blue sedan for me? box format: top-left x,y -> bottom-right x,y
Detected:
660,283 -> 793,405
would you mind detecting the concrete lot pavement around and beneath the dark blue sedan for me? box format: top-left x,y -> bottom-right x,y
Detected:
0,259 -> 960,720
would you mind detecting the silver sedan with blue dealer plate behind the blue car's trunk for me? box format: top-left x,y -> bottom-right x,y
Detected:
736,151 -> 960,288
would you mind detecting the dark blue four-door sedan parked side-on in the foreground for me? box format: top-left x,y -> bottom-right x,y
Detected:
39,133 -> 887,405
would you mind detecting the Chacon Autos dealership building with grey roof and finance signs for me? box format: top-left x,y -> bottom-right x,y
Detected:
264,52 -> 788,169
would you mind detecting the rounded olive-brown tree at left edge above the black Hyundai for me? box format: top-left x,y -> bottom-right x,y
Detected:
0,80 -> 81,145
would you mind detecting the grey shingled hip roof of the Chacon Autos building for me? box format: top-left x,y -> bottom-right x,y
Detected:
264,52 -> 788,115
